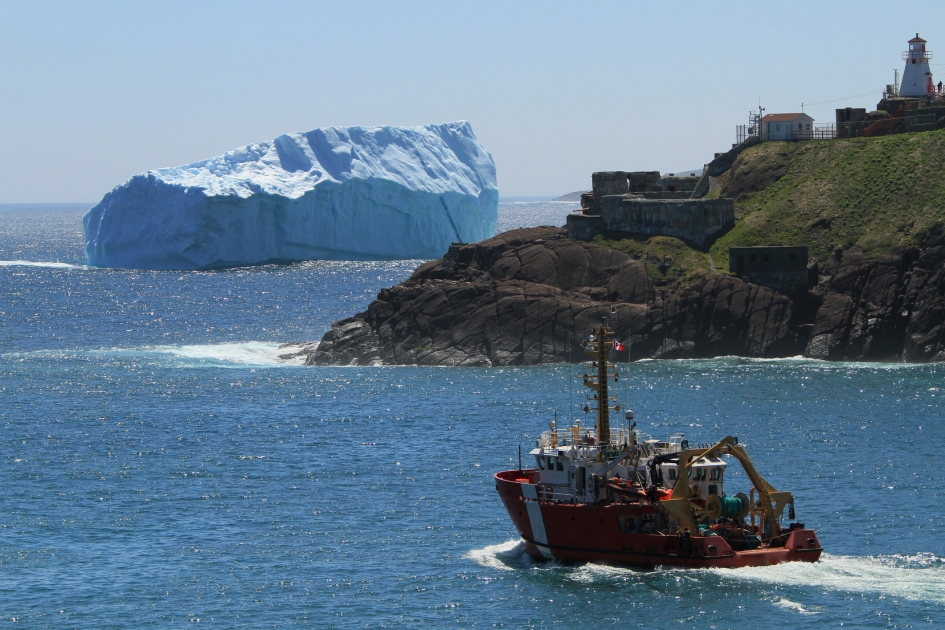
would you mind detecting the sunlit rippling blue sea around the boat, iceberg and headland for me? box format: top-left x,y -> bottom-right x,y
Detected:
0,201 -> 945,628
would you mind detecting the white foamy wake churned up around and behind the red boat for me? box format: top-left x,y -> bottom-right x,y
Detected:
466,540 -> 945,614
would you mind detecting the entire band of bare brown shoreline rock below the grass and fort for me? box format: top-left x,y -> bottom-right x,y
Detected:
296,227 -> 945,366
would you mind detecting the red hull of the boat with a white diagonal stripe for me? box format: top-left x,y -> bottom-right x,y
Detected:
495,470 -> 823,568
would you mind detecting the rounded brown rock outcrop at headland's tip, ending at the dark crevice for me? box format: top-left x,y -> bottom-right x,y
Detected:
306,228 -> 807,365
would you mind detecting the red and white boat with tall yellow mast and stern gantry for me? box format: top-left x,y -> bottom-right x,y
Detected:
495,324 -> 823,568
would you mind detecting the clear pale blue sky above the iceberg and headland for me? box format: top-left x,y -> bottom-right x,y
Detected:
0,0 -> 945,203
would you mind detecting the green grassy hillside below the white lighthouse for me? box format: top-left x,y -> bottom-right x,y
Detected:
710,130 -> 945,269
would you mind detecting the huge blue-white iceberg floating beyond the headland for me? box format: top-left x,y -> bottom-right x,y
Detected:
82,121 -> 499,269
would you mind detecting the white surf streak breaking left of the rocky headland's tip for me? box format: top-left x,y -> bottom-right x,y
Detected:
0,341 -> 304,369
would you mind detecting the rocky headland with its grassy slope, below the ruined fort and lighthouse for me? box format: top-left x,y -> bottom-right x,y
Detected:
286,130 -> 945,366
